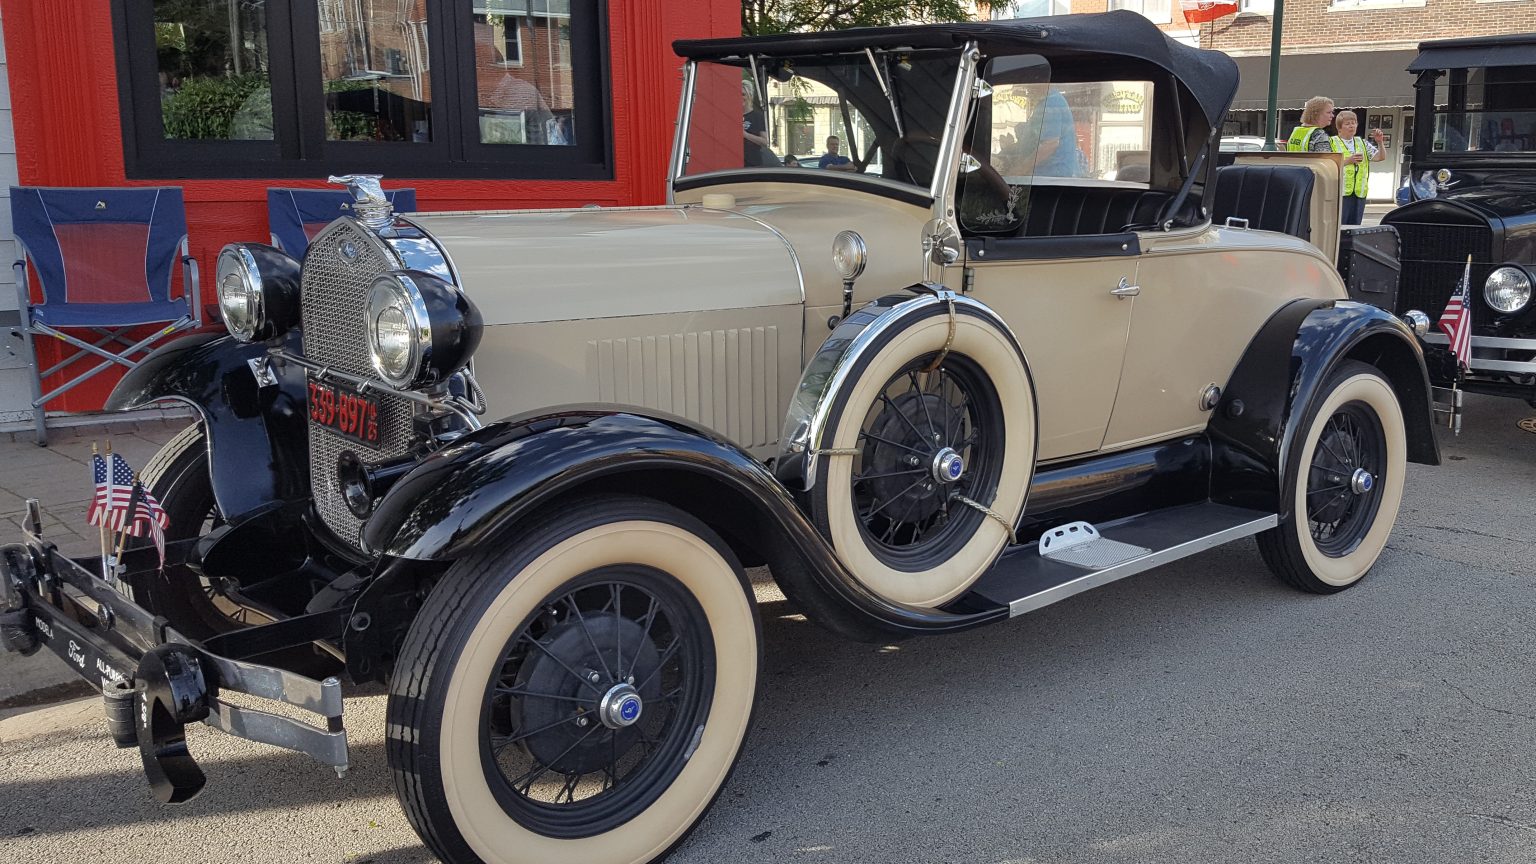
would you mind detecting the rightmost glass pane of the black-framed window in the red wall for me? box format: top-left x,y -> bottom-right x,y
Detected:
475,0 -> 576,146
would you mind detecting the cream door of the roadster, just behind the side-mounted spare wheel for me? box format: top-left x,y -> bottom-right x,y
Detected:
964,257 -> 1137,460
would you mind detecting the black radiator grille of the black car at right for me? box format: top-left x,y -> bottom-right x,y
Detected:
1392,221 -> 1493,321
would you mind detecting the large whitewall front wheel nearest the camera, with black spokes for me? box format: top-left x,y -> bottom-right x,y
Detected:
387,497 -> 760,864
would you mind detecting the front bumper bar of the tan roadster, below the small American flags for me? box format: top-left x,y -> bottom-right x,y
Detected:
0,501 -> 347,804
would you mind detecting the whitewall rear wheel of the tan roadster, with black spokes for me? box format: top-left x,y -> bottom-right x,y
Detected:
1258,361 -> 1407,593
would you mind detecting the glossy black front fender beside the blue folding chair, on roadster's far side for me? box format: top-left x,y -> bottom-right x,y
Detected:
106,332 -> 309,524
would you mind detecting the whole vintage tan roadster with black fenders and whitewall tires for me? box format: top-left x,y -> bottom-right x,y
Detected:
0,12 -> 1439,864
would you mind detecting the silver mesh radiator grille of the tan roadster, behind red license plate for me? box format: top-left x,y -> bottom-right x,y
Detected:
301,220 -> 415,547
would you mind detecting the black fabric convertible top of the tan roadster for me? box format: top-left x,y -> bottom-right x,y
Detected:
673,9 -> 1238,126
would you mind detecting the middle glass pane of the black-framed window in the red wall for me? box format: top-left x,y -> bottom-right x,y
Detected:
319,0 -> 432,141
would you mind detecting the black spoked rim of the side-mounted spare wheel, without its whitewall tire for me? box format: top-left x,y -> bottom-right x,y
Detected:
852,352 -> 1005,570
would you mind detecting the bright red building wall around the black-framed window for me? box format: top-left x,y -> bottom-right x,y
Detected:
0,0 -> 740,410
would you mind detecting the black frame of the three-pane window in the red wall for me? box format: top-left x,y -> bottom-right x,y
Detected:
112,0 -> 614,180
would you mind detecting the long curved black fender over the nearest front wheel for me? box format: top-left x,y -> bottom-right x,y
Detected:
362,407 -> 1008,638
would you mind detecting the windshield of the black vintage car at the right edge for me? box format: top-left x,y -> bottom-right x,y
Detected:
1432,66 -> 1536,154
